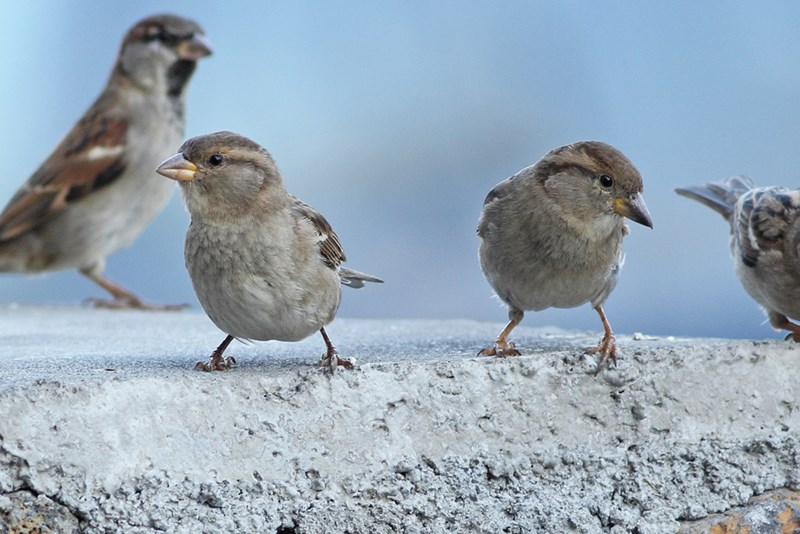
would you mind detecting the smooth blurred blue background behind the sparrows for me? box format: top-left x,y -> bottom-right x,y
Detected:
0,0 -> 800,339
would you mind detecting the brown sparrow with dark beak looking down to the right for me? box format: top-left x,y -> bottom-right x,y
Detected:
478,141 -> 653,371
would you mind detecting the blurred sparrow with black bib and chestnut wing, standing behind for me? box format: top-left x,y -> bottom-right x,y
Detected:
0,15 -> 211,309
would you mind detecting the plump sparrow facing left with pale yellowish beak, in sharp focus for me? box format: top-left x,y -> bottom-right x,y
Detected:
157,132 -> 381,371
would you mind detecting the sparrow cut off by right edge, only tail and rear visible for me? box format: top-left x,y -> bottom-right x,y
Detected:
675,176 -> 800,342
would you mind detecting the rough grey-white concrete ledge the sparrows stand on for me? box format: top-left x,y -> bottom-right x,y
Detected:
0,306 -> 800,534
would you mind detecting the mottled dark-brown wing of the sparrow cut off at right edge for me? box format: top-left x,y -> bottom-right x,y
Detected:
731,187 -> 800,267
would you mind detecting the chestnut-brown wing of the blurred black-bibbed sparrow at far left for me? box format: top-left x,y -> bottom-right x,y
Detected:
0,101 -> 128,240
